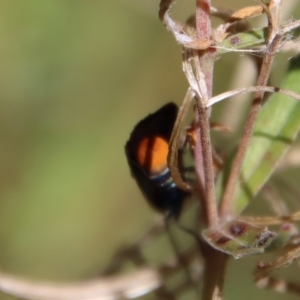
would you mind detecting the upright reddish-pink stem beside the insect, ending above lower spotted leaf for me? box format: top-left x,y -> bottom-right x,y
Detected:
194,0 -> 218,227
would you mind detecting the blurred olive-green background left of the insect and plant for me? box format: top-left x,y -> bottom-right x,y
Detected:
0,0 -> 295,299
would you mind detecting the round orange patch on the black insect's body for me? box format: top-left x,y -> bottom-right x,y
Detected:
137,136 -> 169,174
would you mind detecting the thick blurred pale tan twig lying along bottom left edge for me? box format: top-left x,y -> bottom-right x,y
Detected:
0,268 -> 161,300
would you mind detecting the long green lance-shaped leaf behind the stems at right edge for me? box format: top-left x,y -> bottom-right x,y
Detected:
235,56 -> 300,212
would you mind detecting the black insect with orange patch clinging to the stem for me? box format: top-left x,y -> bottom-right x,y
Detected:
125,103 -> 188,219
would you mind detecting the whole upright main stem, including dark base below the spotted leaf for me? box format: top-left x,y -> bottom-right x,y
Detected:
194,0 -> 228,300
